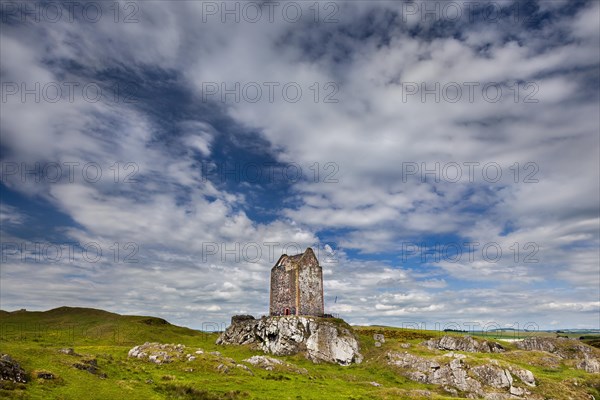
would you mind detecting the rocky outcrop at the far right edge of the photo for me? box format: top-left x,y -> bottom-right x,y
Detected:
517,337 -> 600,374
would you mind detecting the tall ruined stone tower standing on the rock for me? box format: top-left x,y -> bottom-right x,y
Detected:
269,247 -> 325,317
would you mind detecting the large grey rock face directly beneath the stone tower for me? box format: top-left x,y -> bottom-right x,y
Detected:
217,316 -> 362,365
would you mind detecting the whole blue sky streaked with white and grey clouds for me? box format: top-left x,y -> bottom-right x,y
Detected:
0,0 -> 600,329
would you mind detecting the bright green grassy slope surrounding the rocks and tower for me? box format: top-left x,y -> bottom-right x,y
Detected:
0,307 -> 600,400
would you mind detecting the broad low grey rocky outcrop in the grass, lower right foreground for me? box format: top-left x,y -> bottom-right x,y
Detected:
387,352 -> 535,399
